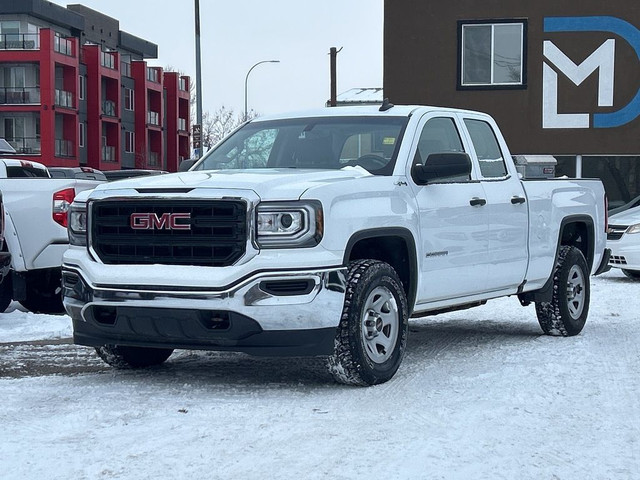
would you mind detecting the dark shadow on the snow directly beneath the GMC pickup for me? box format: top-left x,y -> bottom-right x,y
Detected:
77,320 -> 544,392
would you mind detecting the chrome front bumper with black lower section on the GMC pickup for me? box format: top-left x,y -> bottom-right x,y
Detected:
62,267 -> 346,355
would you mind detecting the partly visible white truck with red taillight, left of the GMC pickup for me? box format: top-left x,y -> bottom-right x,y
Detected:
0,158 -> 100,313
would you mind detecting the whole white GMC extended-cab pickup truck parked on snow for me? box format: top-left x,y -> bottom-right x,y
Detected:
63,103 -> 608,385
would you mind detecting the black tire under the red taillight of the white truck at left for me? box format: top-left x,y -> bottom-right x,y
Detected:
20,269 -> 65,315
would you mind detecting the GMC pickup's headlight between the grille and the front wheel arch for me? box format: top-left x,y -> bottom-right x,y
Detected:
256,201 -> 324,248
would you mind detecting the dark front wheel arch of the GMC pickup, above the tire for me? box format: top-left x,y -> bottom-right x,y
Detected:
343,227 -> 418,313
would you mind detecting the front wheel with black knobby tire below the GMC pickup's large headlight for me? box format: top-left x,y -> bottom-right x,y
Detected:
328,260 -> 409,386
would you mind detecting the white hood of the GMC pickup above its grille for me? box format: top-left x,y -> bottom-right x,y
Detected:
96,167 -> 371,200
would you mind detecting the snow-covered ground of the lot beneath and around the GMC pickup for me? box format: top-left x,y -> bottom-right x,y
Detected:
0,271 -> 640,480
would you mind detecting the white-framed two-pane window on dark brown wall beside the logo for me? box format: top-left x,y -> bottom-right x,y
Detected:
458,20 -> 527,88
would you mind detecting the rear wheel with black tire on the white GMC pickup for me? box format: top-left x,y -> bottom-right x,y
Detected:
536,245 -> 591,337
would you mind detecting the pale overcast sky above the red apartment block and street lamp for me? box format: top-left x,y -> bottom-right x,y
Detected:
54,0 -> 383,114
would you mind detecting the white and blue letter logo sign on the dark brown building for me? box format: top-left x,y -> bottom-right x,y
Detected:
542,17 -> 640,129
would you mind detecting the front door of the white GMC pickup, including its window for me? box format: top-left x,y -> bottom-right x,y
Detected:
412,113 -> 489,310
